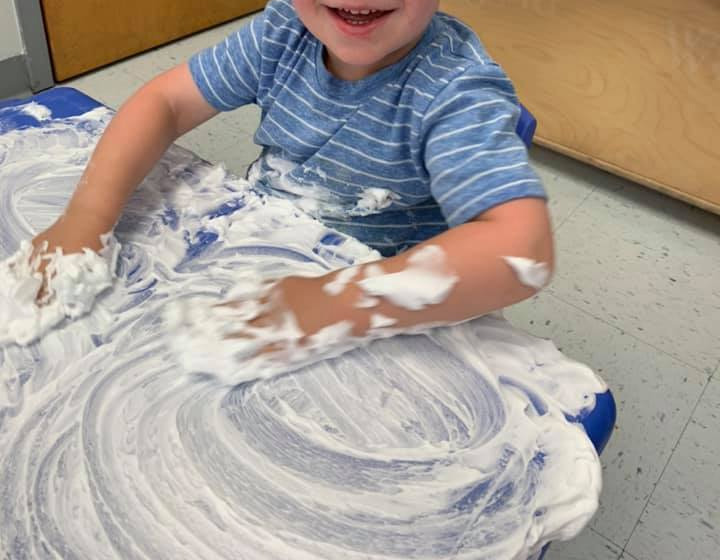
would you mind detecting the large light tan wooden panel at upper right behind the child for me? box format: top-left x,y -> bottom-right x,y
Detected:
441,0 -> 720,213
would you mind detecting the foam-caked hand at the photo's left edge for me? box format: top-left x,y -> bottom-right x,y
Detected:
0,235 -> 120,346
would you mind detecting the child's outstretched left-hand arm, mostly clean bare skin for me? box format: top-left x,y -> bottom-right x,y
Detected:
33,64 -> 217,253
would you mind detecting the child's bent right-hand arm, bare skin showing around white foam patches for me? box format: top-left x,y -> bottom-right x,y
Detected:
236,198 -> 554,342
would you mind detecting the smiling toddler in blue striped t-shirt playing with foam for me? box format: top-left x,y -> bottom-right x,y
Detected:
34,0 -> 553,346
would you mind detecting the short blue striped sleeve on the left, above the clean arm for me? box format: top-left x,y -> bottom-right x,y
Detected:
190,12 -> 266,111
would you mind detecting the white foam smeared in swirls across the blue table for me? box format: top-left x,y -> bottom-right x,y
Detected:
0,100 -> 605,560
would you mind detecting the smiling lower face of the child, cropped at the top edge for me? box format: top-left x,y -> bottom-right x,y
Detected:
294,0 -> 439,80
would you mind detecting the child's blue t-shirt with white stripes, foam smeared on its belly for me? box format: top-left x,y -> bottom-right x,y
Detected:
190,0 -> 545,255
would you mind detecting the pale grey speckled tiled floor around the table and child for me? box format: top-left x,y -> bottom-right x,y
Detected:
21,12 -> 720,560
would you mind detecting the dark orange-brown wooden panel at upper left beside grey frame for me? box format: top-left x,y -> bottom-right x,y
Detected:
42,0 -> 265,81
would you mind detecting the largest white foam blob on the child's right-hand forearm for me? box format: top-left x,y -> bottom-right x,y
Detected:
358,245 -> 458,311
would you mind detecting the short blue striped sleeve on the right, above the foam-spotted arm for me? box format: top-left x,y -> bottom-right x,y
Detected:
423,64 -> 546,227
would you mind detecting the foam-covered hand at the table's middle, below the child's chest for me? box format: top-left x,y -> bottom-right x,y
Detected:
166,276 -> 354,383
